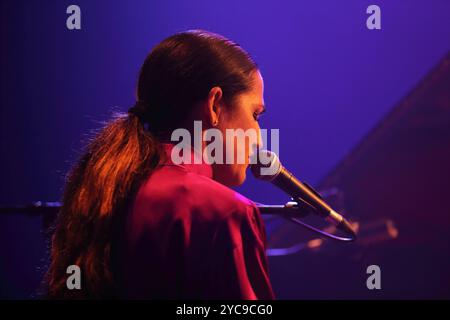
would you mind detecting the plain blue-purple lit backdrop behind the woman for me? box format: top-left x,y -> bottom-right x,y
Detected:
0,0 -> 450,298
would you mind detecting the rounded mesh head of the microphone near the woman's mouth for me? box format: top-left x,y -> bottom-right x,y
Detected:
250,150 -> 282,181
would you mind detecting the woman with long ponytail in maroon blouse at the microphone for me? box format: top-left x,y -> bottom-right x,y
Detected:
47,30 -> 274,299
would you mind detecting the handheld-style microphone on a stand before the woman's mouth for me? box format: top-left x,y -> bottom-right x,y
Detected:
250,150 -> 356,237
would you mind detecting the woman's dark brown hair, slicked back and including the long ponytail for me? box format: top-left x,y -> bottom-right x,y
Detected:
46,30 -> 257,298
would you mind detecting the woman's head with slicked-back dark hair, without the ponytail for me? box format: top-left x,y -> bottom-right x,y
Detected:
137,30 -> 264,185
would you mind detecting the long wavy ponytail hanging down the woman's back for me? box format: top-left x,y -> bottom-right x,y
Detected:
47,113 -> 162,298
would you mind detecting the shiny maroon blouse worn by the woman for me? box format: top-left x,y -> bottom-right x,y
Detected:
118,144 -> 274,299
